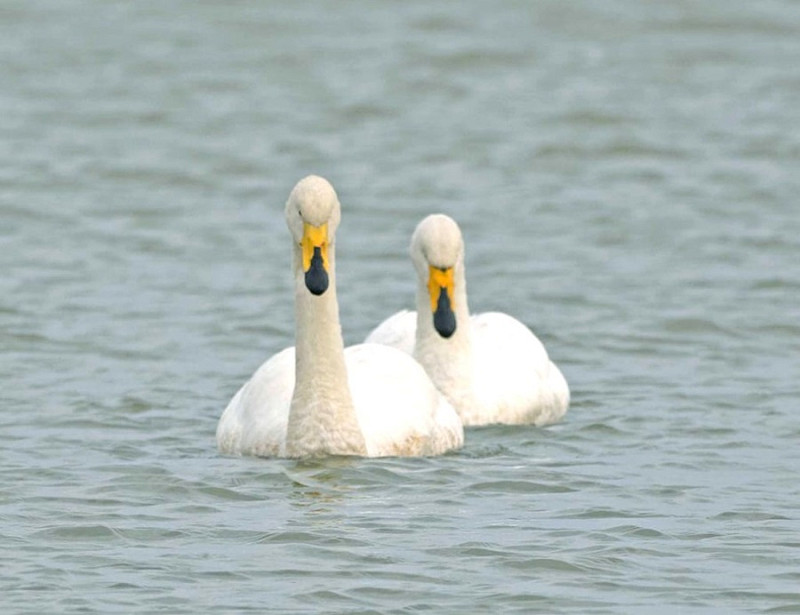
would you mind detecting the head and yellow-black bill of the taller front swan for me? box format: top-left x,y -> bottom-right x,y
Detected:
286,175 -> 342,295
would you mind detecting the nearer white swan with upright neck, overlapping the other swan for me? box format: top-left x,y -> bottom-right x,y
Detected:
217,175 -> 464,458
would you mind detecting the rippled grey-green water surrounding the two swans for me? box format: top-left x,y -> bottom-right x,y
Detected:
0,0 -> 800,614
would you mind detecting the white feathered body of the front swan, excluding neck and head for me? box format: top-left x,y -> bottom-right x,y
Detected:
217,344 -> 464,457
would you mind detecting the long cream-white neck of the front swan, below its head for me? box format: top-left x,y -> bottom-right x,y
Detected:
286,245 -> 366,457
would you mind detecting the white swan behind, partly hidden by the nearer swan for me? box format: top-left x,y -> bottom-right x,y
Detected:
366,214 -> 569,425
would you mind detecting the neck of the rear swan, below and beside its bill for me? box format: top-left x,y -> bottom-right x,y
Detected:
414,260 -> 475,411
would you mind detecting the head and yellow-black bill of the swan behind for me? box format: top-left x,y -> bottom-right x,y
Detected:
411,214 -> 464,338
